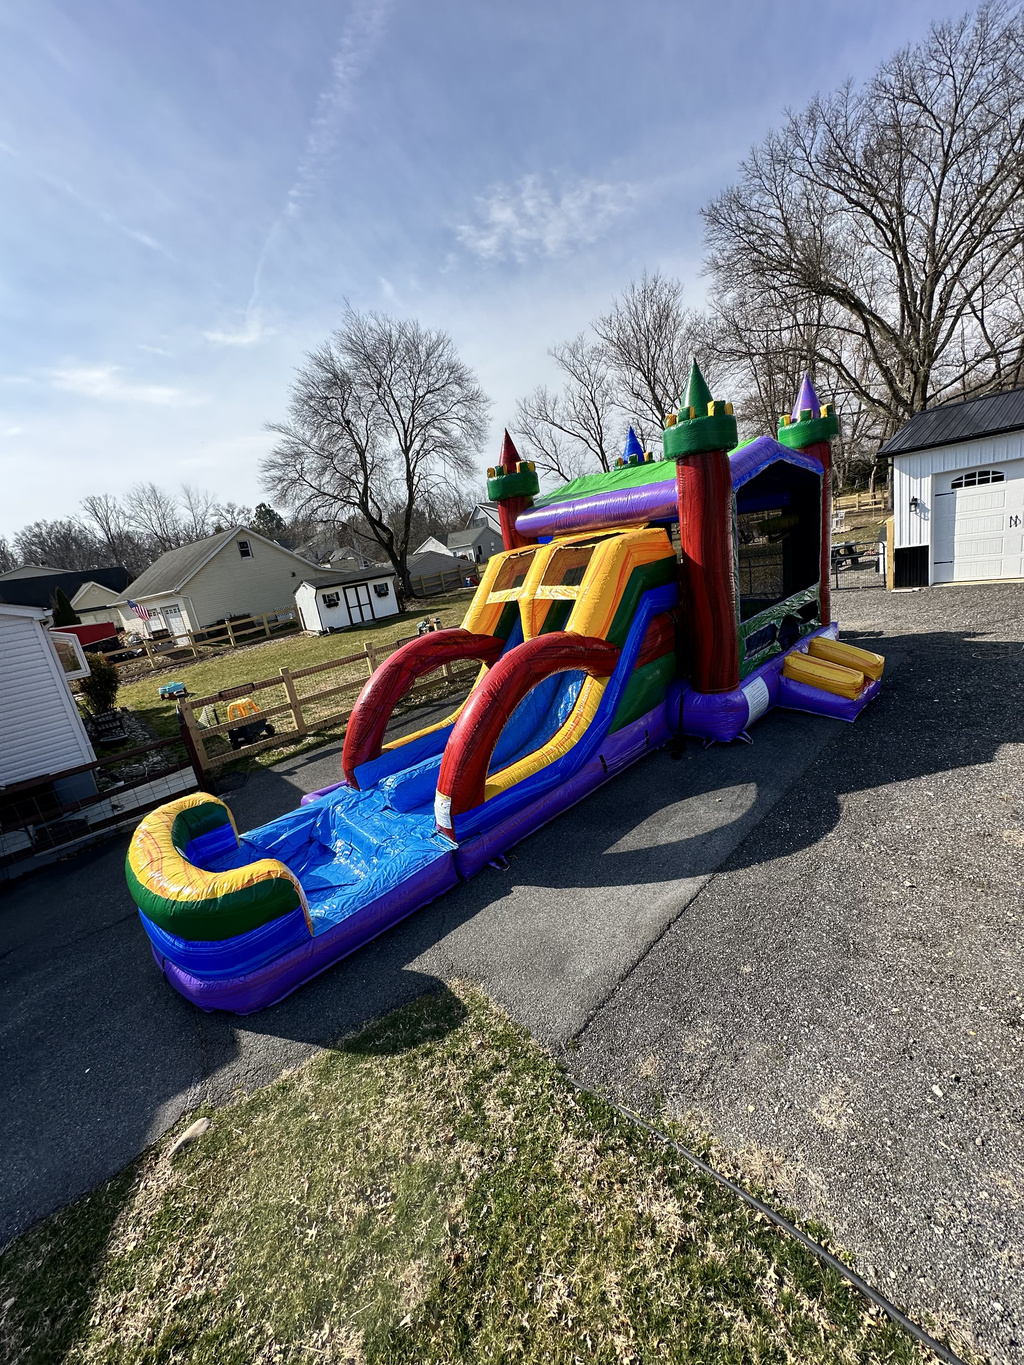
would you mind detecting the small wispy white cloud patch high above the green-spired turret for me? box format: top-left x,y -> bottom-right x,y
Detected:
456,175 -> 636,261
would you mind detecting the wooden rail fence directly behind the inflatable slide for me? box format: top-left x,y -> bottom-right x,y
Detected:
180,636 -> 479,773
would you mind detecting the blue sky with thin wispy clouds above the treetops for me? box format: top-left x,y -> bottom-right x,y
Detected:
0,0 -> 944,535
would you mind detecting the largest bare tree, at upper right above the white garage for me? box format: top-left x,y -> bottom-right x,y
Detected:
705,0 -> 1024,440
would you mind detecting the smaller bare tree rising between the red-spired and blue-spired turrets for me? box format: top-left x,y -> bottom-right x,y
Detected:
515,332 -> 623,480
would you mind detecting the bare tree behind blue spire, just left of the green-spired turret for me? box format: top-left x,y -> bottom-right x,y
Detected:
594,270 -> 714,436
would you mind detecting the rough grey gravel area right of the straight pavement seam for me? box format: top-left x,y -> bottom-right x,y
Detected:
567,580 -> 1024,1361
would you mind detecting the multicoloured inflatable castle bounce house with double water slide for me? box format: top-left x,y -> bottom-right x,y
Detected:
127,364 -> 883,1014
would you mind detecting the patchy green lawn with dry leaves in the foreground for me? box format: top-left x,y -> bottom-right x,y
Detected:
0,988 -> 961,1365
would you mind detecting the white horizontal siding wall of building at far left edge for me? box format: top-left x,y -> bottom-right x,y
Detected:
0,612 -> 96,786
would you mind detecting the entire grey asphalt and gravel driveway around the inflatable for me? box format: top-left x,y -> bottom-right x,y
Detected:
0,586 -> 1024,1358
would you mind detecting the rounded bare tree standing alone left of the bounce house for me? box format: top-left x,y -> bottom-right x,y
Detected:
262,308 -> 489,595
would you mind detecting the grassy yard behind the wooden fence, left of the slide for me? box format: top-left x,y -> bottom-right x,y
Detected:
117,588 -> 474,767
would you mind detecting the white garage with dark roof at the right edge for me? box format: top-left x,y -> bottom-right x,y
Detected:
882,389 -> 1024,588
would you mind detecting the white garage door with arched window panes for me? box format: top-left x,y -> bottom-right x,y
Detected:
931,460 -> 1024,583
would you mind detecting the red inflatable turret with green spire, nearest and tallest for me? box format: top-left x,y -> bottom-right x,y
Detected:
662,360 -> 740,692
